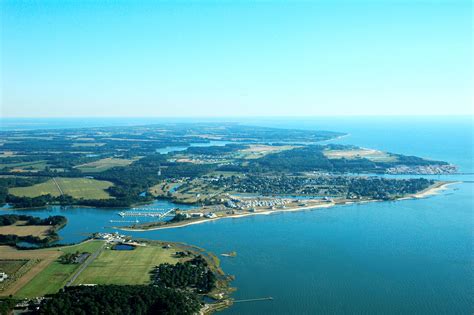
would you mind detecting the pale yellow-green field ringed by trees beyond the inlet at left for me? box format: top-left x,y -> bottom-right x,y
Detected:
8,178 -> 113,199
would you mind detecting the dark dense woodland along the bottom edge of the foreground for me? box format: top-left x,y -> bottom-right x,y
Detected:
34,285 -> 201,315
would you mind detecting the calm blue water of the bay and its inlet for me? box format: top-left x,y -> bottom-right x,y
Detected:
1,118 -> 474,314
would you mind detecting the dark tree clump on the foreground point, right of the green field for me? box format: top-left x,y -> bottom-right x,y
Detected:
151,256 -> 217,293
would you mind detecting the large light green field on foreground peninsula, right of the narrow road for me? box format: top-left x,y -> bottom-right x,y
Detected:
74,245 -> 178,284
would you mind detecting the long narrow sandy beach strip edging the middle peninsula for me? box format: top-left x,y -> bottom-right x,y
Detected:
118,181 -> 460,232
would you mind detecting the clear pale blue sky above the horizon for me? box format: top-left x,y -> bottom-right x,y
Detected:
0,0 -> 473,117
